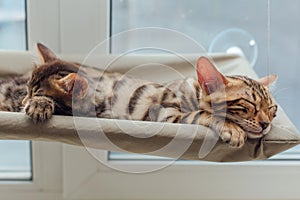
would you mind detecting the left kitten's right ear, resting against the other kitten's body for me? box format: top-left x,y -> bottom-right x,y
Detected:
58,73 -> 88,99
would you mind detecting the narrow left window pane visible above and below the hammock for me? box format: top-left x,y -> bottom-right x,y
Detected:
0,0 -> 31,180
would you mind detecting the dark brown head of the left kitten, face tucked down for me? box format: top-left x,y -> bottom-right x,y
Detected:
23,43 -> 88,112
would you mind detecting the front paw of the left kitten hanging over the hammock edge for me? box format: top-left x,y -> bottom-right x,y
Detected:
25,96 -> 54,123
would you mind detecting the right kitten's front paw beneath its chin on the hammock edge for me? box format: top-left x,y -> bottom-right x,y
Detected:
220,123 -> 247,148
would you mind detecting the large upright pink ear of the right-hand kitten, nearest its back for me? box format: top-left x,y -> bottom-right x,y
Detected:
197,57 -> 228,94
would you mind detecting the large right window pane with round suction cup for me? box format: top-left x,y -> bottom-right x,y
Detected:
111,0 -> 300,159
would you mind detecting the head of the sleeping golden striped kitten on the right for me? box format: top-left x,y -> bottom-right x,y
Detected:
197,57 -> 277,138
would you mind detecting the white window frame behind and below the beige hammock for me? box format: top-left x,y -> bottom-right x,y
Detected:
0,0 -> 300,200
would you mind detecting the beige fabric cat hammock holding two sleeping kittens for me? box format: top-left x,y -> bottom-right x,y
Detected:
0,52 -> 300,162
